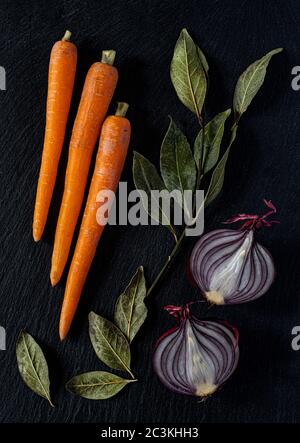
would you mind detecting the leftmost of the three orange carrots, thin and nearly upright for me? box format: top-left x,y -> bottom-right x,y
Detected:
32,31 -> 77,241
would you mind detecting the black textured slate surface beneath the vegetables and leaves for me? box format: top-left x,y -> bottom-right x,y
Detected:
0,0 -> 300,423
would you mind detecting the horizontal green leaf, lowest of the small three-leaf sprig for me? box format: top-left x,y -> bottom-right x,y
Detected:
66,371 -> 137,400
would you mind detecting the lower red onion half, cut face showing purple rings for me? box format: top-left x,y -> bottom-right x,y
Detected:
153,305 -> 239,397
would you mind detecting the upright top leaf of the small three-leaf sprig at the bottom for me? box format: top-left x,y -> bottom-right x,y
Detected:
115,266 -> 147,342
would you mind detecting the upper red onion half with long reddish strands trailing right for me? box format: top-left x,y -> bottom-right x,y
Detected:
190,200 -> 276,305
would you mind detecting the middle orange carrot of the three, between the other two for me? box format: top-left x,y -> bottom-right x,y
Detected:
50,51 -> 118,286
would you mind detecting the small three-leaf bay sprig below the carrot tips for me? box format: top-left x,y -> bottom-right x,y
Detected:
66,267 -> 147,400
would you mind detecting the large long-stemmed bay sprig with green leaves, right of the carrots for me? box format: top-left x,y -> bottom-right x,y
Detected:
133,29 -> 282,295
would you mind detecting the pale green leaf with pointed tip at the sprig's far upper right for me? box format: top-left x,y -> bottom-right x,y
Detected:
233,48 -> 282,120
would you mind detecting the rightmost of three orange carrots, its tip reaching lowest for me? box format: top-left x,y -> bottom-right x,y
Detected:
59,103 -> 131,340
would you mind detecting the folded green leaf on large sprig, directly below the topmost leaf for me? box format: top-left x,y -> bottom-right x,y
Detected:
194,109 -> 231,174
